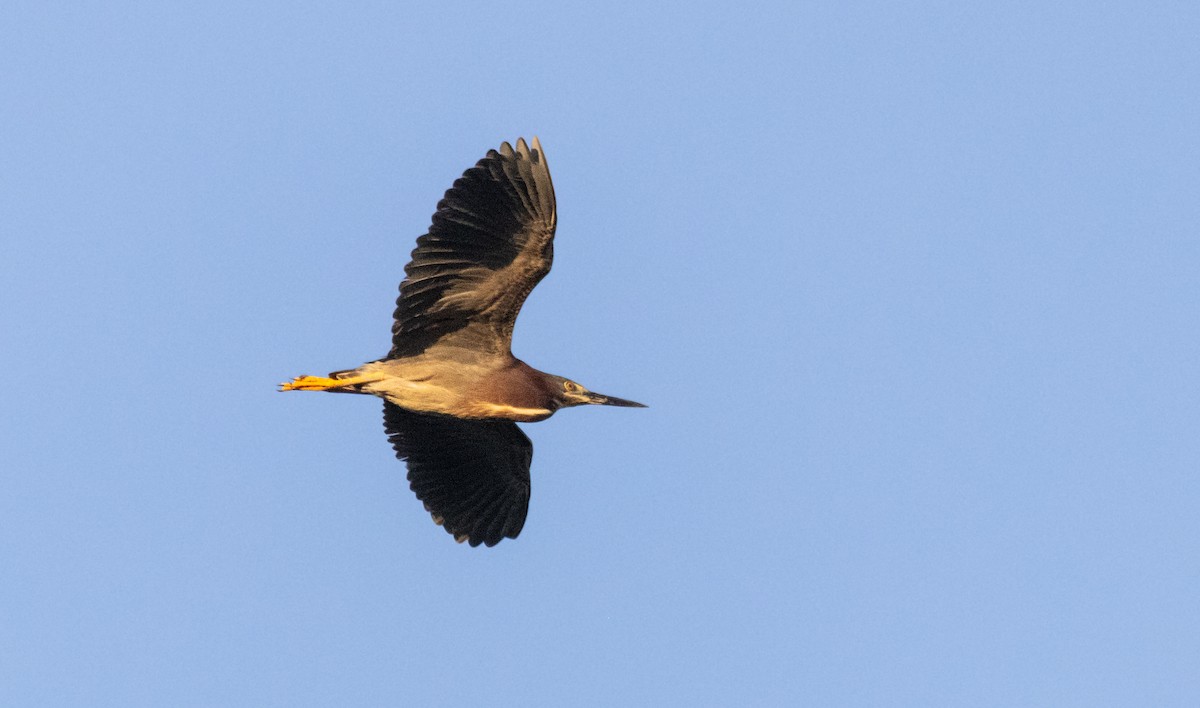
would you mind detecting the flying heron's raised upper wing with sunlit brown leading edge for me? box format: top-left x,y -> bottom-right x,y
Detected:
388,138 -> 557,359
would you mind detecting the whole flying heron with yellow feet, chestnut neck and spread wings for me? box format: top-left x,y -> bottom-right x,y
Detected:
280,137 -> 644,546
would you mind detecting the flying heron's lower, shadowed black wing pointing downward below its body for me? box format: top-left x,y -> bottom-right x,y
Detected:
383,402 -> 533,546
